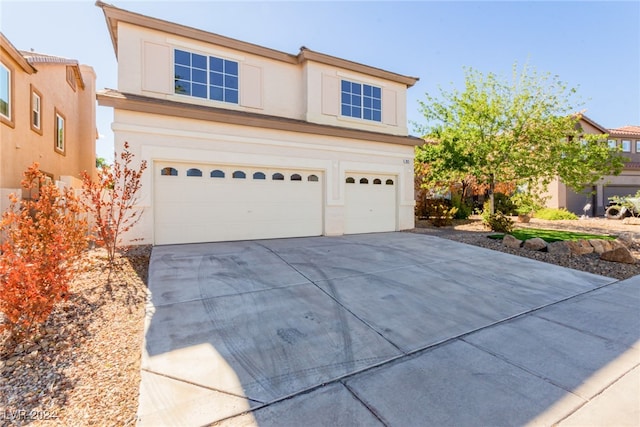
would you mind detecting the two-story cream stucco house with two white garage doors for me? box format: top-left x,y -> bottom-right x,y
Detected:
97,2 -> 422,244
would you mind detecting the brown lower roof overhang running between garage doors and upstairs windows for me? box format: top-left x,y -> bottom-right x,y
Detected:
97,89 -> 424,146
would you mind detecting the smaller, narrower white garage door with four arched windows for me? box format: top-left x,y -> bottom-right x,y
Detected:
344,174 -> 397,234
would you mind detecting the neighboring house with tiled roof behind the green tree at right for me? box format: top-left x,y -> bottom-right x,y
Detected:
547,116 -> 640,216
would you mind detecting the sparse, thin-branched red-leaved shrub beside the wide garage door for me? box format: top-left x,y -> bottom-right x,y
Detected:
82,142 -> 147,266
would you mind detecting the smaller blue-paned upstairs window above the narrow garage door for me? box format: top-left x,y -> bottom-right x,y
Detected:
340,80 -> 382,122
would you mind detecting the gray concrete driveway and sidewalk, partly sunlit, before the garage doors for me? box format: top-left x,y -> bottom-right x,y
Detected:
138,233 -> 640,426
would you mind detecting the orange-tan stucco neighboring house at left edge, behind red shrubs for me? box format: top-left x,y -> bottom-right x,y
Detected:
0,33 -> 96,210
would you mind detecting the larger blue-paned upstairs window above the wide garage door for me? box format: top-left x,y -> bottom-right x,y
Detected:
174,49 -> 238,104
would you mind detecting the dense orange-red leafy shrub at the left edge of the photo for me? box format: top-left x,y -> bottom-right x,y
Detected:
0,163 -> 87,340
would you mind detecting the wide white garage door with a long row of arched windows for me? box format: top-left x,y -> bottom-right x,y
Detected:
153,162 -> 324,244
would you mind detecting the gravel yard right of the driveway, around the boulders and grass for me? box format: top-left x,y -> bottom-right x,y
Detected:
412,217 -> 640,280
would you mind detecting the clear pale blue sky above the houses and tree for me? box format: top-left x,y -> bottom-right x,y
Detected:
0,0 -> 640,159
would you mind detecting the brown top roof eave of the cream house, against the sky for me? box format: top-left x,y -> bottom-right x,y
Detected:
96,0 -> 419,87
